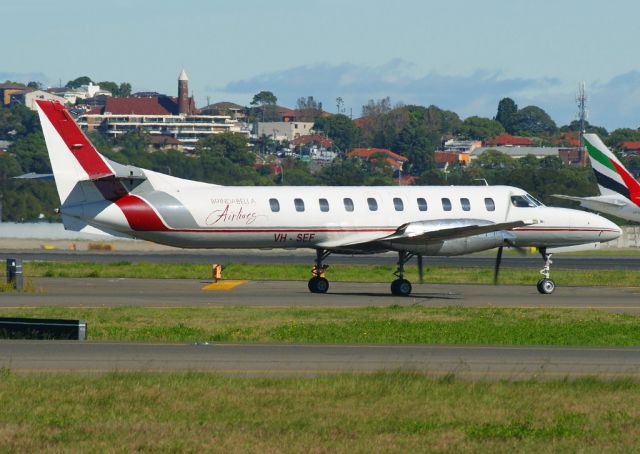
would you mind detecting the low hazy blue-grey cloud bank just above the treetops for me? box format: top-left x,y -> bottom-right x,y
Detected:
218,59 -> 640,130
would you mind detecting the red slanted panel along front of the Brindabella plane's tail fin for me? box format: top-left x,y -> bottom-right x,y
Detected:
36,101 -> 113,179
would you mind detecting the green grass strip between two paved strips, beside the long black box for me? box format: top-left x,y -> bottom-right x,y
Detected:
0,306 -> 640,346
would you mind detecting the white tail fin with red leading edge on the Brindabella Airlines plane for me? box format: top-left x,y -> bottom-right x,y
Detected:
36,100 -> 114,205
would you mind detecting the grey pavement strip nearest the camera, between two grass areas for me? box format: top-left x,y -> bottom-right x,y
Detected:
0,341 -> 640,380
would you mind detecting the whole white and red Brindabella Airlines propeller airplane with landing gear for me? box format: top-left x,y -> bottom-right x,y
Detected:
37,101 -> 620,295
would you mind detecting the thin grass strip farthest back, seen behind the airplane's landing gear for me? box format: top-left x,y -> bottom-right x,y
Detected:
7,258 -> 640,287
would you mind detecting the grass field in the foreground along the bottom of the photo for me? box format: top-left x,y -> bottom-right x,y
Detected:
0,371 -> 640,453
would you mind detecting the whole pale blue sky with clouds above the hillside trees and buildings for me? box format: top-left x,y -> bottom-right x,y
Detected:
5,0 -> 640,130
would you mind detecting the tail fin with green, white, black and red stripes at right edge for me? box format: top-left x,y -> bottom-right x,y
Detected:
584,134 -> 640,206
